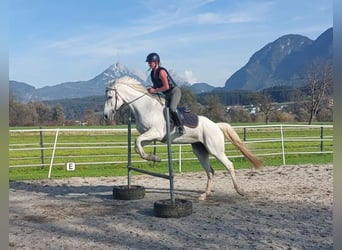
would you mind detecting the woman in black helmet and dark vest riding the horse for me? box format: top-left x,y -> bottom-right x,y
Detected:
145,52 -> 184,134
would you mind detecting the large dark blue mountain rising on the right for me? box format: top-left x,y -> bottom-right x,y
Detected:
223,28 -> 332,91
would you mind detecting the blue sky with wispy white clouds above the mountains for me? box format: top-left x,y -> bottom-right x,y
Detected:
9,0 -> 333,87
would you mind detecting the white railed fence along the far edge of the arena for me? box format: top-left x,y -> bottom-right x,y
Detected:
9,124 -> 333,178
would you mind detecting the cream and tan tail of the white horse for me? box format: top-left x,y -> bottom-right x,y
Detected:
216,122 -> 264,168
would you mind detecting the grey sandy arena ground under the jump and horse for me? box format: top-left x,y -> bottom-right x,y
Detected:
9,164 -> 333,250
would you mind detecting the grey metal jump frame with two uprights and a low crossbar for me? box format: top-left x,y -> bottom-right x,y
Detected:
127,108 -> 175,204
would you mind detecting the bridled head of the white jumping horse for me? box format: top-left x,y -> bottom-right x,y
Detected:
103,80 -> 124,121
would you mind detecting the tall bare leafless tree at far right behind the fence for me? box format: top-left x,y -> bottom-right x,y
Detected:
305,60 -> 333,125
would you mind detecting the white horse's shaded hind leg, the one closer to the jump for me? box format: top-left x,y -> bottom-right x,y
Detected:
191,142 -> 214,200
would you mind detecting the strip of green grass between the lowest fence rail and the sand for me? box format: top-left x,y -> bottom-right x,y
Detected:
9,151 -> 333,181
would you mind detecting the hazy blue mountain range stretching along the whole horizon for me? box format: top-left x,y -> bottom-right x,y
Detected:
9,28 -> 333,102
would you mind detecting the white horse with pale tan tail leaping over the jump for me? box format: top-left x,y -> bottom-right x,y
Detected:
104,76 -> 263,200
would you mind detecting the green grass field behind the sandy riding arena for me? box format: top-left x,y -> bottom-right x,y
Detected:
9,124 -> 333,180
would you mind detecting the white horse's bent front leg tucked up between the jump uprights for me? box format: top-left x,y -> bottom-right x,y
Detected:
135,130 -> 161,161
